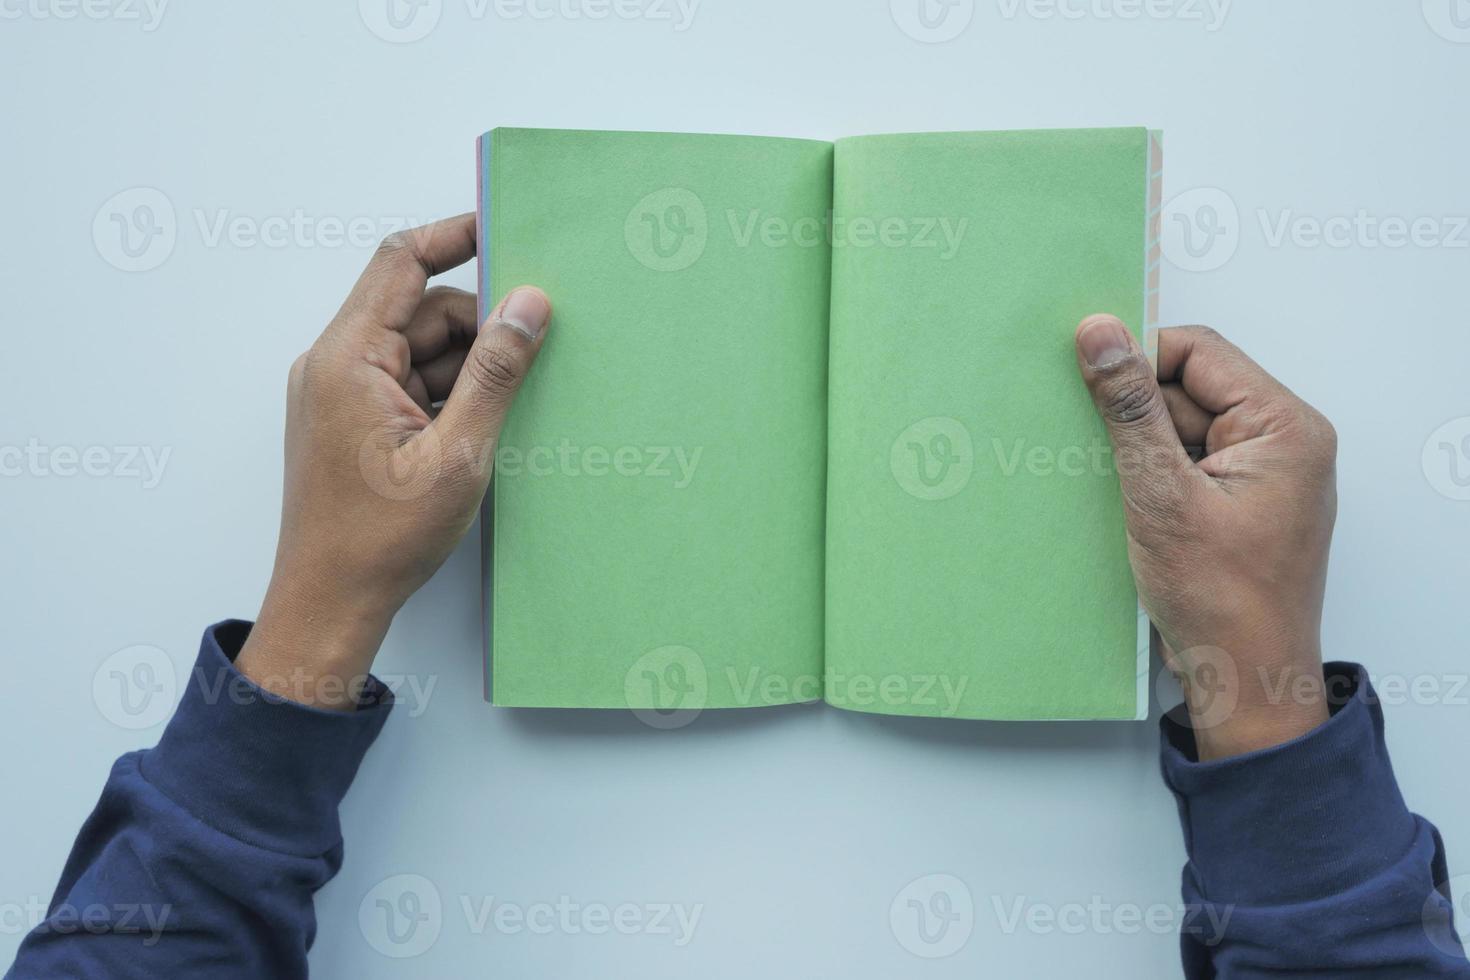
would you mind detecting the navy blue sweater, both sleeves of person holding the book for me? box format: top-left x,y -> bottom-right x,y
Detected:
6,621 -> 1470,979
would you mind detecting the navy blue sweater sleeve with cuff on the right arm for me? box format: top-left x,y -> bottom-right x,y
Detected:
1163,663 -> 1470,979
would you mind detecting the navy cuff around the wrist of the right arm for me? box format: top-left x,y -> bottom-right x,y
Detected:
1160,663 -> 1416,905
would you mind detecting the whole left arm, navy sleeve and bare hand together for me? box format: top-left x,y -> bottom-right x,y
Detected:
5,221 -> 538,977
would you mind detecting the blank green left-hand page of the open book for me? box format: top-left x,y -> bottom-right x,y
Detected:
481,129 -> 832,708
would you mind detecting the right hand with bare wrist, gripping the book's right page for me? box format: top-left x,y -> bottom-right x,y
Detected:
1076,314 -> 1336,760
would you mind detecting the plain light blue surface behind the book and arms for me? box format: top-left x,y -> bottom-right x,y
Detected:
0,0 -> 1470,979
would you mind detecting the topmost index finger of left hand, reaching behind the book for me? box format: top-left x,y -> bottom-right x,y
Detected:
332,215 -> 475,336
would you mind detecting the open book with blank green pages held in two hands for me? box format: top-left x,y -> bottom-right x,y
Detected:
479,129 -> 1160,720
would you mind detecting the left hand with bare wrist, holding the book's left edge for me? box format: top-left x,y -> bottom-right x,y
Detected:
235,215 -> 551,710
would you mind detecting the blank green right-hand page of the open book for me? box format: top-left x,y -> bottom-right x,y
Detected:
826,129 -> 1148,718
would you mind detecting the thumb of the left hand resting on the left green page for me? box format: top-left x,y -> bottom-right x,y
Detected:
434,287 -> 551,480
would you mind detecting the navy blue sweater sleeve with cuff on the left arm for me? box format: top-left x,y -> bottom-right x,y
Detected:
6,620 -> 392,980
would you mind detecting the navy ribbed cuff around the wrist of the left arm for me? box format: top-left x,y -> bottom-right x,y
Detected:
141,620 -> 392,855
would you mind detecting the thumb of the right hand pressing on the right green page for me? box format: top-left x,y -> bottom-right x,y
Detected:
1076,313 -> 1191,510
